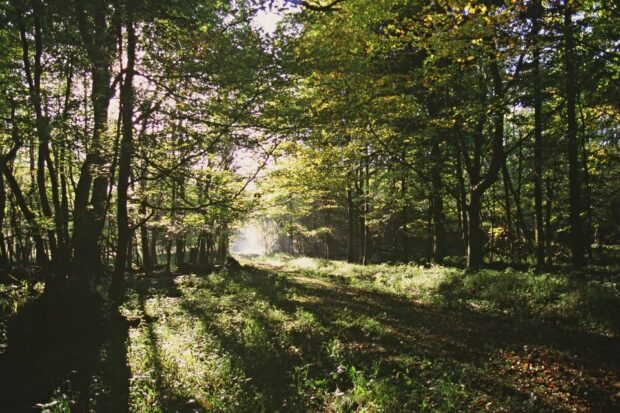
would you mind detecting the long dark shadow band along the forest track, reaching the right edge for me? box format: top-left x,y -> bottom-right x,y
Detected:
237,268 -> 620,369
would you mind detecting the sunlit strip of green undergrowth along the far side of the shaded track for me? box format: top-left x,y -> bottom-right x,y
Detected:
241,254 -> 620,335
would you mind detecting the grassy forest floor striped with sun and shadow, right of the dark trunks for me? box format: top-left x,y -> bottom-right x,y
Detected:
123,256 -> 620,412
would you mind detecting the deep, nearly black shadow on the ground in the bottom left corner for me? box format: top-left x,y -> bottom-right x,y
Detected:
0,280 -> 129,412
